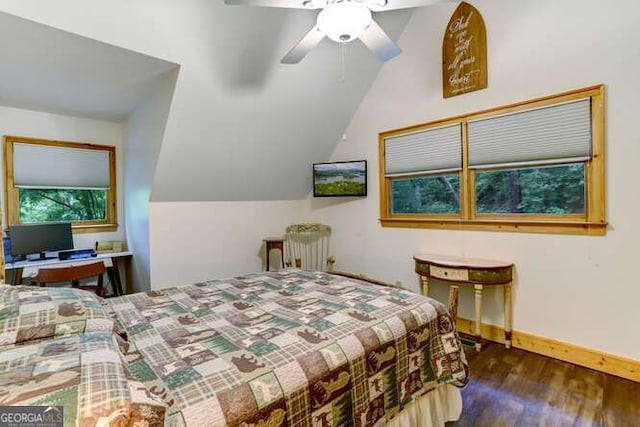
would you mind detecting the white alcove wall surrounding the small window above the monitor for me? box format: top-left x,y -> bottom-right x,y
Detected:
0,106 -> 125,249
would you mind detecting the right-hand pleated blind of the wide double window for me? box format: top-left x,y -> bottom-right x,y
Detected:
468,99 -> 592,169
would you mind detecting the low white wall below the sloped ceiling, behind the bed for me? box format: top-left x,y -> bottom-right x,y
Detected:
149,200 -> 308,289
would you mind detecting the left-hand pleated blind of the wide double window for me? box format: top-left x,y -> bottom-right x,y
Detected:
384,123 -> 462,177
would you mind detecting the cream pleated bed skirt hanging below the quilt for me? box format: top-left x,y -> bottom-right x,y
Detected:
386,384 -> 462,427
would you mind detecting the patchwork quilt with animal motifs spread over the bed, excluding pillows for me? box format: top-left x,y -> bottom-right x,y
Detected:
108,270 -> 468,427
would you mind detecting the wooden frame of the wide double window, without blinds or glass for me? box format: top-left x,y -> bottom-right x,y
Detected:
378,85 -> 607,235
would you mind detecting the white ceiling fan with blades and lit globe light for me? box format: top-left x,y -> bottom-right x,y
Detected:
224,0 -> 451,64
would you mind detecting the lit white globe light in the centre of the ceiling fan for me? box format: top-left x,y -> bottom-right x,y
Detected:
318,1 -> 371,43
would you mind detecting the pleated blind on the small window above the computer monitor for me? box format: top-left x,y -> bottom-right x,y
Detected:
13,143 -> 111,189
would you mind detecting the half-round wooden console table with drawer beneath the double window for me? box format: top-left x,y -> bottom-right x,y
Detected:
413,254 -> 513,351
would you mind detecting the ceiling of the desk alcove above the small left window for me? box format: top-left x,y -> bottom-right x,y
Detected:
0,13 -> 176,121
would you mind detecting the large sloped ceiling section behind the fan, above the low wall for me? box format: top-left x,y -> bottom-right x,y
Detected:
0,0 -> 411,201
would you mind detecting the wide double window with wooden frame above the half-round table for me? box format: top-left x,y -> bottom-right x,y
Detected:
380,86 -> 606,234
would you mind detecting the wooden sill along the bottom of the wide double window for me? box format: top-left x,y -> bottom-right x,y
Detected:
380,217 -> 607,236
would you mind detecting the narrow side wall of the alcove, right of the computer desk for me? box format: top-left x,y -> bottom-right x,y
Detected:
124,69 -> 178,291
